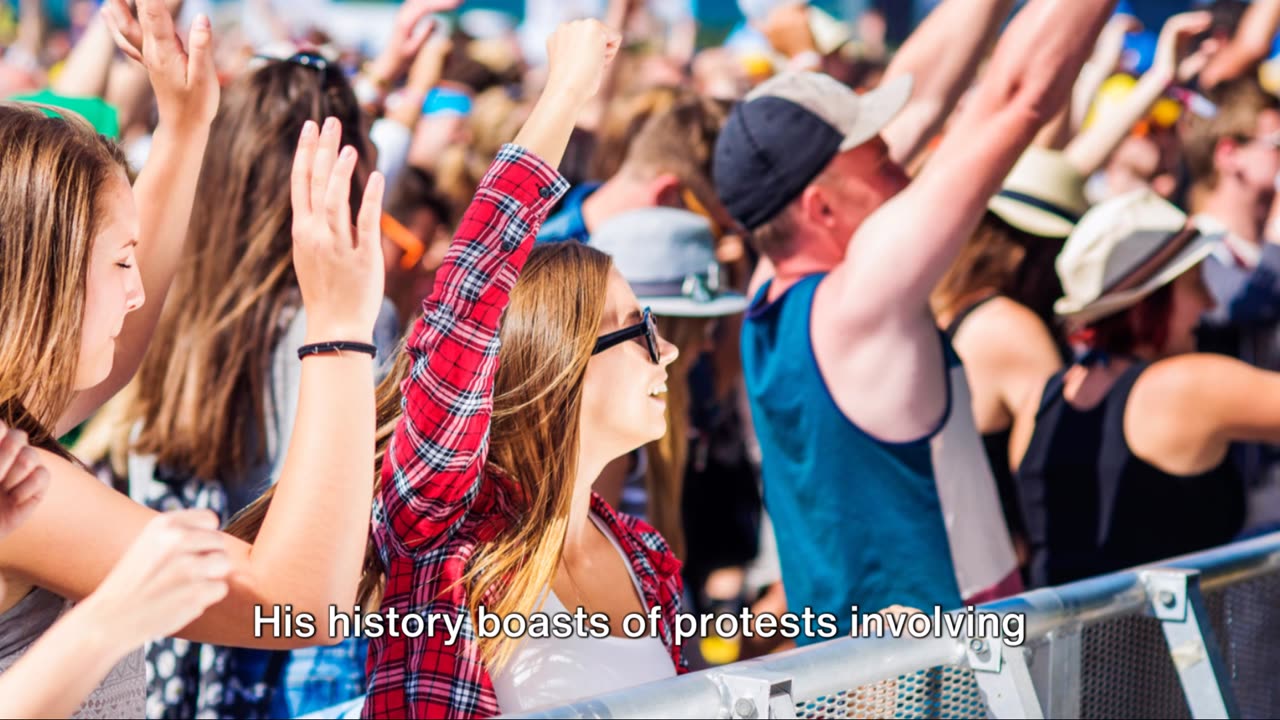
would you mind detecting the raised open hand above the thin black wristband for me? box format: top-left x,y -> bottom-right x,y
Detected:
291,118 -> 385,342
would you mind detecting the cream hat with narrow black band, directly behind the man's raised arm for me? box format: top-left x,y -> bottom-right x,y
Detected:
987,146 -> 1089,237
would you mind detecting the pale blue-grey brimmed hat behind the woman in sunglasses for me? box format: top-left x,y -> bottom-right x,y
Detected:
590,208 -> 748,318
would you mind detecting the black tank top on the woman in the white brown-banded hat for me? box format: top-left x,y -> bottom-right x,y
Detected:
1018,363 -> 1244,587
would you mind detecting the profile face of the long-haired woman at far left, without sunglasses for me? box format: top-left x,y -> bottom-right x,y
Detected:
76,173 -> 146,391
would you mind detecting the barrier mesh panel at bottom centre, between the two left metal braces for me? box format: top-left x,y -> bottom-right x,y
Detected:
796,665 -> 987,719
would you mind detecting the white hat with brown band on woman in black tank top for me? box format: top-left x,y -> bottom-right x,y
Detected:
1053,188 -> 1222,325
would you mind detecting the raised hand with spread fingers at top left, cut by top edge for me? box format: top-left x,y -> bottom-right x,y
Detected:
102,0 -> 219,128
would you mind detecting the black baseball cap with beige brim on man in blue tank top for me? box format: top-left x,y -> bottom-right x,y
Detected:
712,72 -> 913,229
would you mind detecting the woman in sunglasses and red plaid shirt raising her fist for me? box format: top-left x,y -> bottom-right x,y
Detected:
225,20 -> 684,717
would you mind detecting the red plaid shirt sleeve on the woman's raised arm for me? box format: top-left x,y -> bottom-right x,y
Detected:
381,145 -> 568,552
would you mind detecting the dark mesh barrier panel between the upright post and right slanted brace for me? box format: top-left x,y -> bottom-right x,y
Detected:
1080,616 -> 1190,719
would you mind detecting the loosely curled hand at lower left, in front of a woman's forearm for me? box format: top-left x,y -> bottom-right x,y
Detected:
81,510 -> 232,647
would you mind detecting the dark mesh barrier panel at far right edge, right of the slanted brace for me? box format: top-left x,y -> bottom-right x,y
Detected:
1204,574 -> 1280,717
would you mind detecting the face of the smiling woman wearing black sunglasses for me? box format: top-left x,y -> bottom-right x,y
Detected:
581,269 -> 680,457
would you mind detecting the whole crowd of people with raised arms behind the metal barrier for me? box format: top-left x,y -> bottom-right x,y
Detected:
0,0 -> 1280,717
